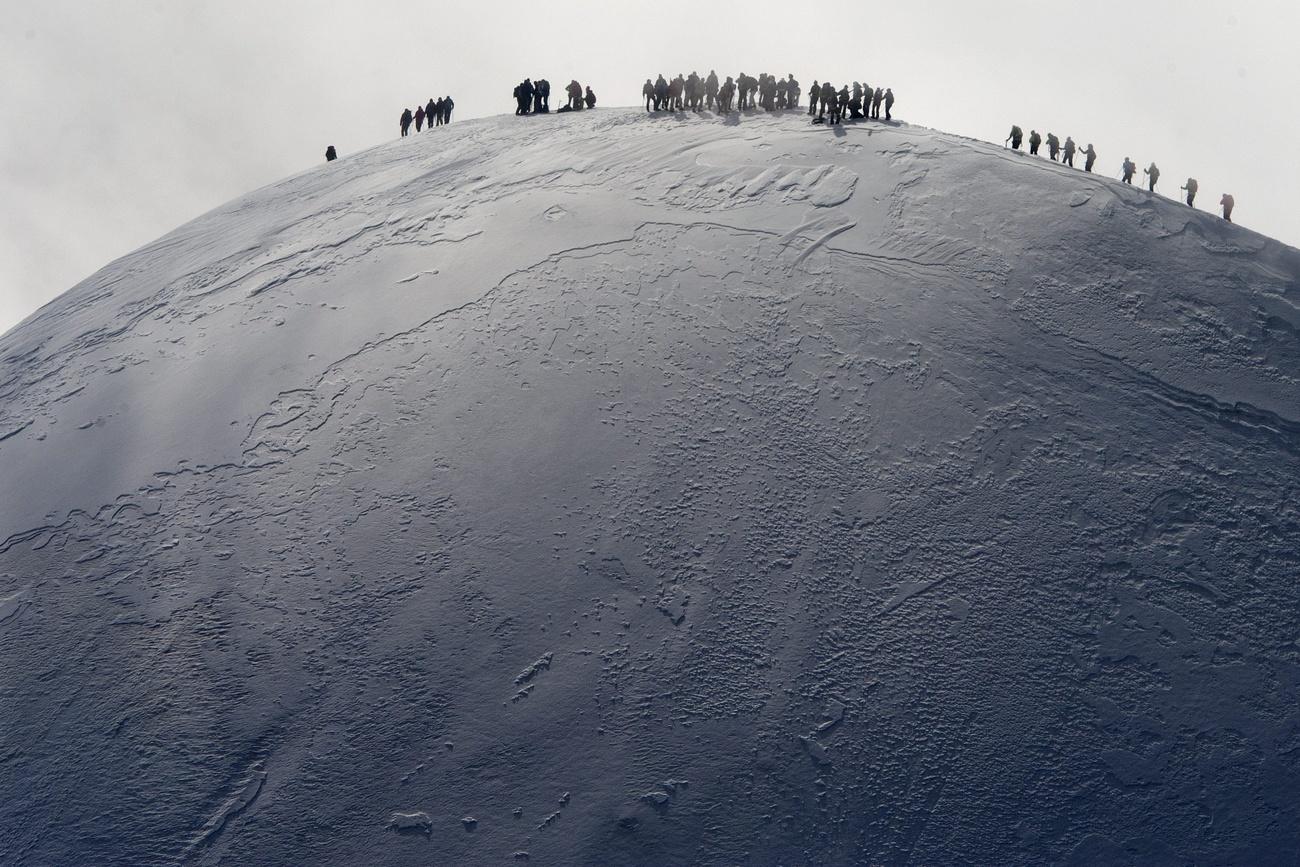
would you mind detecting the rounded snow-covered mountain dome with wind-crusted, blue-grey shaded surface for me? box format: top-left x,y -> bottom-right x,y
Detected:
0,109 -> 1300,864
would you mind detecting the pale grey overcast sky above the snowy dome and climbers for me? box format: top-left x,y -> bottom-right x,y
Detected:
0,0 -> 1300,331
